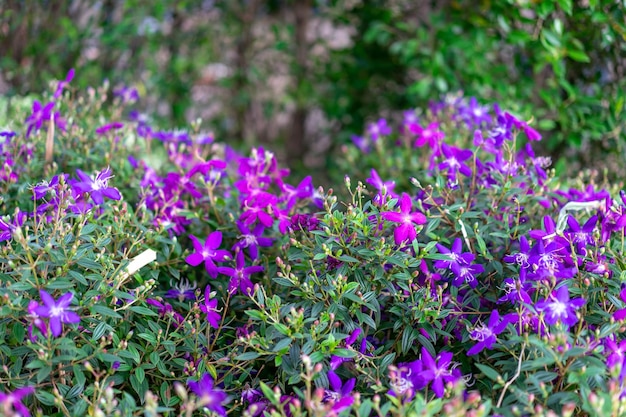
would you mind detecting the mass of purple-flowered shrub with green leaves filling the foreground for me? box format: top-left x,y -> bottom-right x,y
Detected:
0,76 -> 626,416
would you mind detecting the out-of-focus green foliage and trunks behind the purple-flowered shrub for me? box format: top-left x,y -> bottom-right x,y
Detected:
0,0 -> 626,182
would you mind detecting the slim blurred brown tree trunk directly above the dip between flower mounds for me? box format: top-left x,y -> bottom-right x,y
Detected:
285,0 -> 313,167
